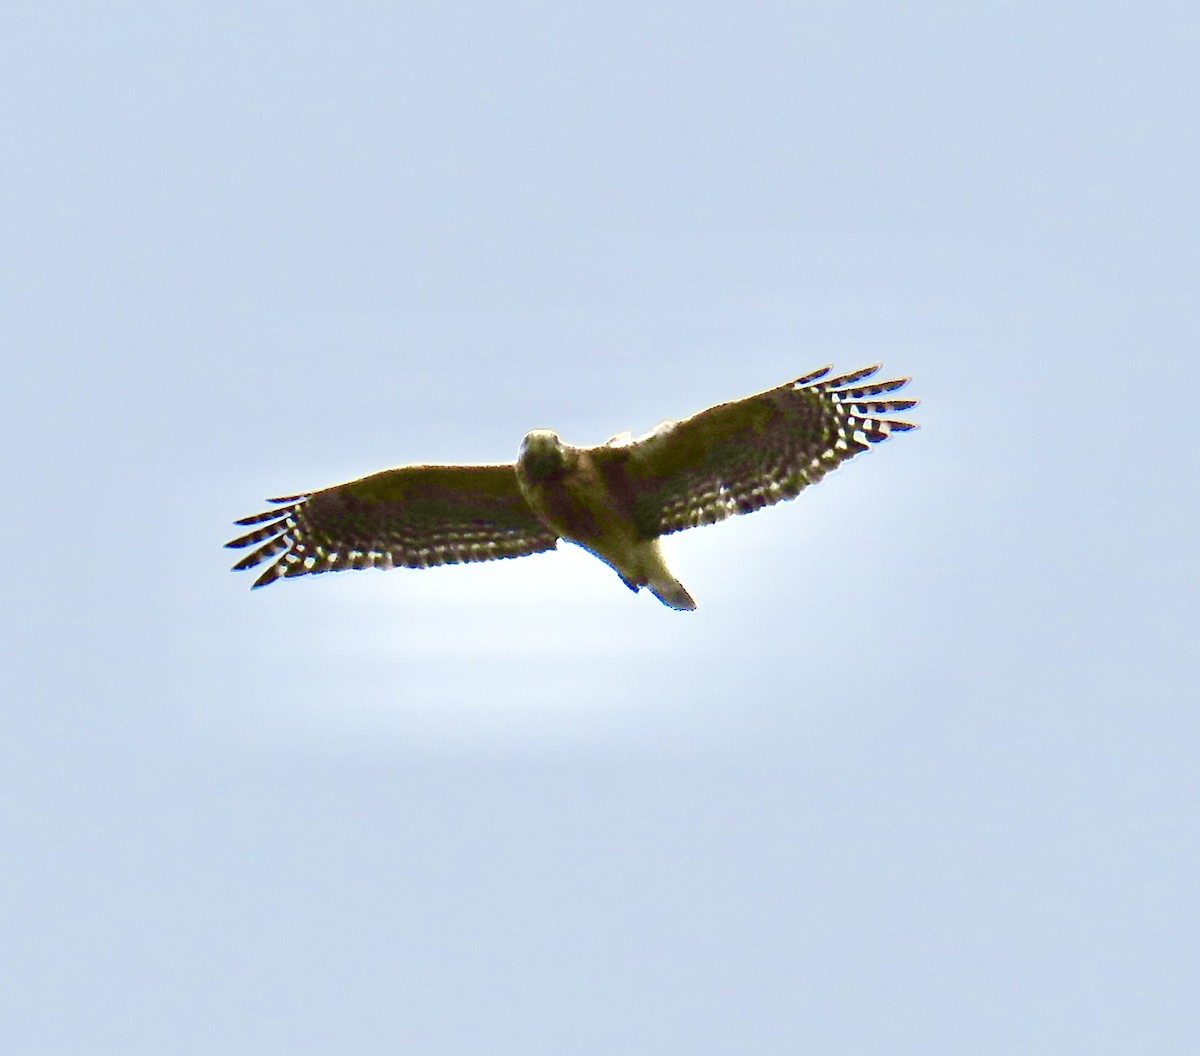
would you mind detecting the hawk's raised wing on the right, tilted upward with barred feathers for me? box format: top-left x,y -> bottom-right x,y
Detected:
612,365 -> 918,539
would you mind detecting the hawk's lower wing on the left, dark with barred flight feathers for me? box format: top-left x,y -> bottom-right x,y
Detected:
226,466 -> 557,587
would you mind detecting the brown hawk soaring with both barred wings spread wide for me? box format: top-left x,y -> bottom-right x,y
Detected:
226,364 -> 918,610
